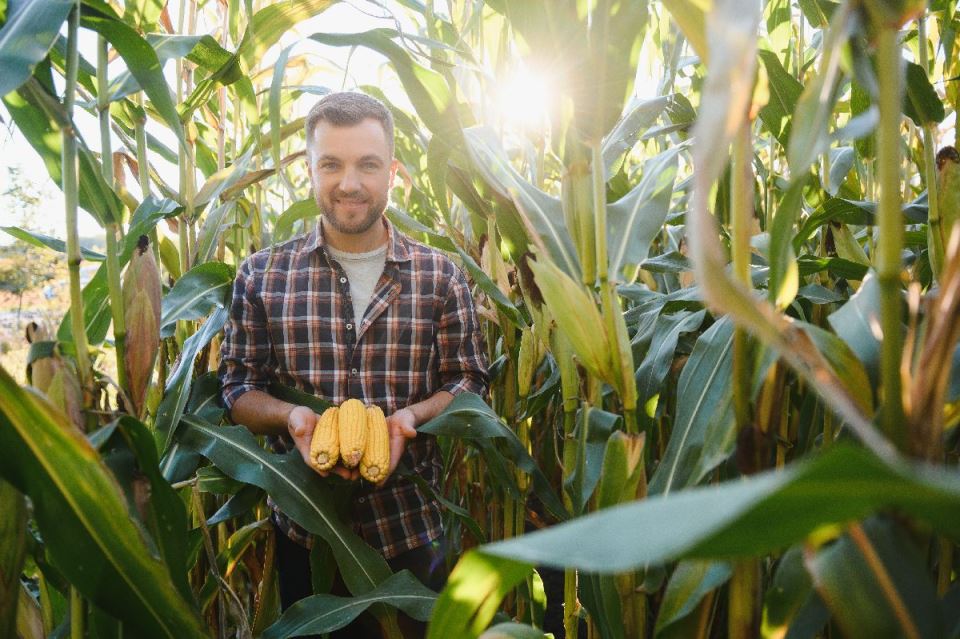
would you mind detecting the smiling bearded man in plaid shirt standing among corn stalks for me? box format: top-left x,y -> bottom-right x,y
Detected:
219,93 -> 487,632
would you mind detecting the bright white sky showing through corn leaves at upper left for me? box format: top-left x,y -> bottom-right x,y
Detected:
0,1 -> 415,245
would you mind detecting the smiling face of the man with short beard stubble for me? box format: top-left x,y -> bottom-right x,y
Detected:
307,118 -> 396,234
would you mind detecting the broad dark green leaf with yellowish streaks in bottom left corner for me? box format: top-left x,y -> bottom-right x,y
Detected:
0,369 -> 206,639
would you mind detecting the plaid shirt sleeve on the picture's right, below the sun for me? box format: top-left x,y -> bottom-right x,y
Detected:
437,267 -> 489,395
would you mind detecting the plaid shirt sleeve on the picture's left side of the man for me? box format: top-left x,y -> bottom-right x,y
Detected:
217,260 -> 272,411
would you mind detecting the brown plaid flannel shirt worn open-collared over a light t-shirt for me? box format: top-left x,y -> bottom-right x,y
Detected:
219,222 -> 487,559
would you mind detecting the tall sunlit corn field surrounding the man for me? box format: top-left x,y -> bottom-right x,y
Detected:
0,0 -> 960,639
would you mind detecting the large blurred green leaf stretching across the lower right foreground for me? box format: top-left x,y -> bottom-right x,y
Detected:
476,444 -> 960,576
